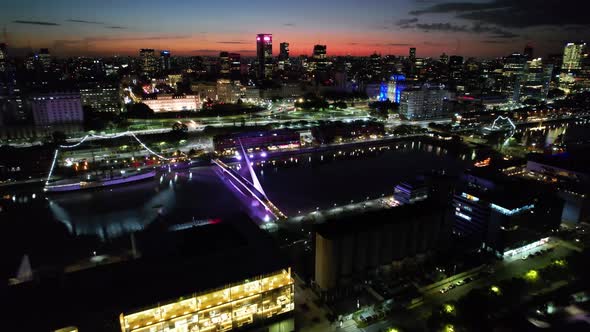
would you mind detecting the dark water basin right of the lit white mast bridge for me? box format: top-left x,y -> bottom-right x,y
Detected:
256,141 -> 471,215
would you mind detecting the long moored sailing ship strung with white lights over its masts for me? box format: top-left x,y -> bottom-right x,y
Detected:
43,169 -> 156,192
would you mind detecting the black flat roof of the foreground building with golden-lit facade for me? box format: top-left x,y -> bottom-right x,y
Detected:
4,219 -> 288,331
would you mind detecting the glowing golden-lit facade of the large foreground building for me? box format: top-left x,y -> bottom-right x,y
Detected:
120,268 -> 294,332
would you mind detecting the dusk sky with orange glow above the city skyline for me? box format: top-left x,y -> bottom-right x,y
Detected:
0,0 -> 590,57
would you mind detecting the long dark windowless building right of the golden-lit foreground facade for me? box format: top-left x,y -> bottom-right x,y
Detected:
314,200 -> 450,300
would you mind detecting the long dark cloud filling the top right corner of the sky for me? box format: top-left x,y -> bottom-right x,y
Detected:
410,0 -> 590,28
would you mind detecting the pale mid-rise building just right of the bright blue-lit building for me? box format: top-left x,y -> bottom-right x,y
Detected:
399,84 -> 451,120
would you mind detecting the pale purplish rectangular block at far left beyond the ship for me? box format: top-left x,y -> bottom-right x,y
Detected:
29,92 -> 84,126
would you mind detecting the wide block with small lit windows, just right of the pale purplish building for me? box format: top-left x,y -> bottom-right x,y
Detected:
80,83 -> 122,112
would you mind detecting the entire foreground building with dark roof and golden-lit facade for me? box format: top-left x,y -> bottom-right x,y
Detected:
3,221 -> 294,332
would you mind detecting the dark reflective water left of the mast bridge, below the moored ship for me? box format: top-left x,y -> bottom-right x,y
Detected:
2,166 -> 241,240
